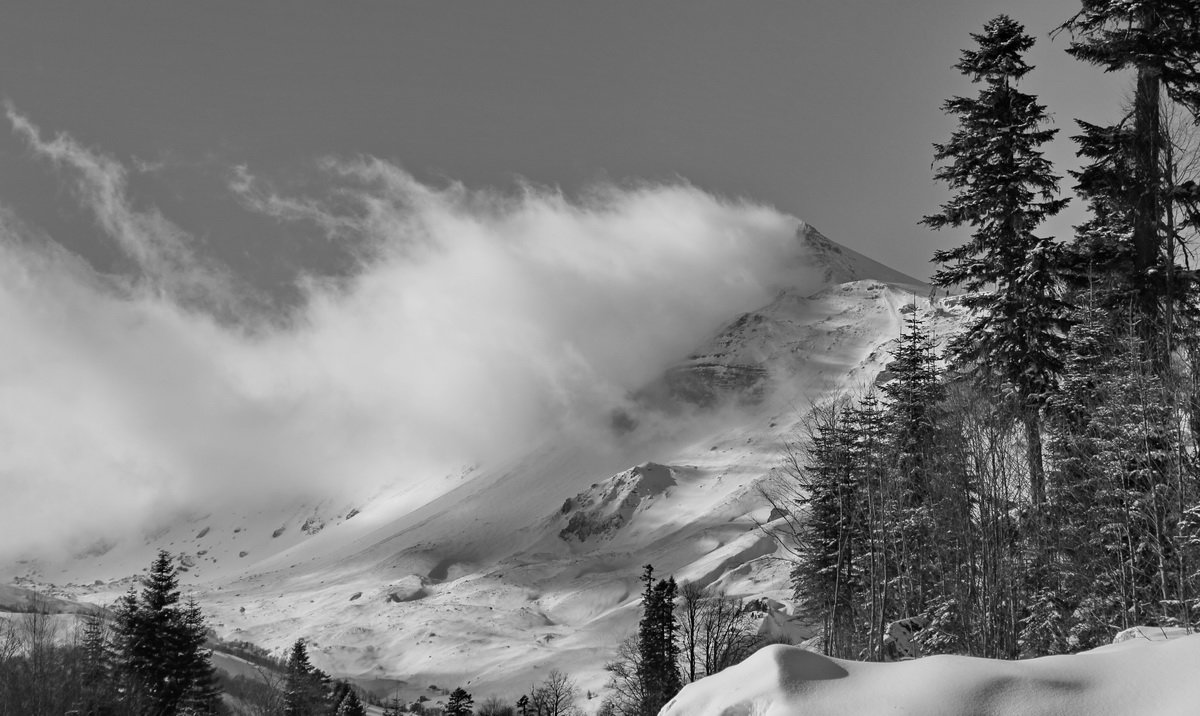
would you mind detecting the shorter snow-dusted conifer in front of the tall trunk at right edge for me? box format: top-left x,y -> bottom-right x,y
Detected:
1022,286 -> 1196,652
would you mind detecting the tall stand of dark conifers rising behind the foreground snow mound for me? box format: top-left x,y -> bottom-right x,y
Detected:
768,0 -> 1200,658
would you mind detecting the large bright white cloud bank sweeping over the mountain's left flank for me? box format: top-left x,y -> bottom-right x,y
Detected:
0,107 -> 817,558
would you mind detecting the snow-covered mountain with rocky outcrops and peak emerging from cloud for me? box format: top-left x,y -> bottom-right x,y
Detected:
0,225 -> 960,696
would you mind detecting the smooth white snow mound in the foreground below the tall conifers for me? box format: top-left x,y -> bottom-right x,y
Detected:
660,634 -> 1200,716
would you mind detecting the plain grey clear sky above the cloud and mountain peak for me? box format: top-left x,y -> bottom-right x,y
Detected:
0,0 -> 1122,282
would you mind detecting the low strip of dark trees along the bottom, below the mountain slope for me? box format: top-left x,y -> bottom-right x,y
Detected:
0,550 -> 710,716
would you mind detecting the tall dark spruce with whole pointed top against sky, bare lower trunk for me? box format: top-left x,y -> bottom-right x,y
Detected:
923,14 -> 1067,505
